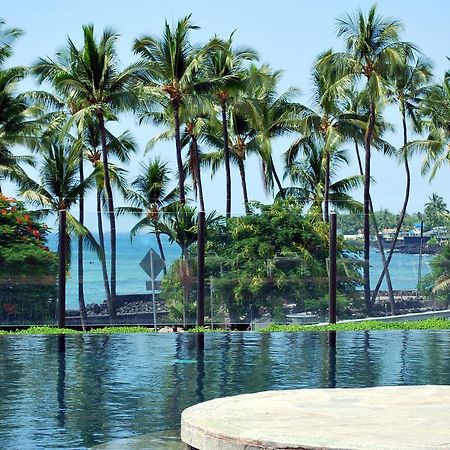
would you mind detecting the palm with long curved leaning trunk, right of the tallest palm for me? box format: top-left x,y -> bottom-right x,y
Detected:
372,58 -> 432,306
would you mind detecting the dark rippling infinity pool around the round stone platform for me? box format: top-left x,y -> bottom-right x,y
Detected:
0,331 -> 450,450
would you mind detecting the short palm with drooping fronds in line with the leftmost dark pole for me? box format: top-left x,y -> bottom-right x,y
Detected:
19,137 -> 99,328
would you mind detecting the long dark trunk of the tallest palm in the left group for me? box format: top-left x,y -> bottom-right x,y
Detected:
98,112 -> 117,319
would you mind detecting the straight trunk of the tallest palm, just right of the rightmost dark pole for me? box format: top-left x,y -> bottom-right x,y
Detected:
363,100 -> 376,315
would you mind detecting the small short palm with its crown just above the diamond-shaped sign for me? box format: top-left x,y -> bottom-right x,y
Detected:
117,158 -> 178,271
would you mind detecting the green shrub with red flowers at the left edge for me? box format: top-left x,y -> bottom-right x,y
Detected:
0,194 -> 57,324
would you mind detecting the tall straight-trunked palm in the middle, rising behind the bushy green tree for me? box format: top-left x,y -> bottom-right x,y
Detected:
204,33 -> 257,218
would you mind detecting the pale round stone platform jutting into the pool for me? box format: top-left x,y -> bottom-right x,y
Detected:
181,386 -> 450,450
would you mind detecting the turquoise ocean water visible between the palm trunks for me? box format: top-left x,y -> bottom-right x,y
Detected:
49,233 -> 431,309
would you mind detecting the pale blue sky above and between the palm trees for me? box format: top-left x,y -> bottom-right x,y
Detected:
0,0 -> 450,230
